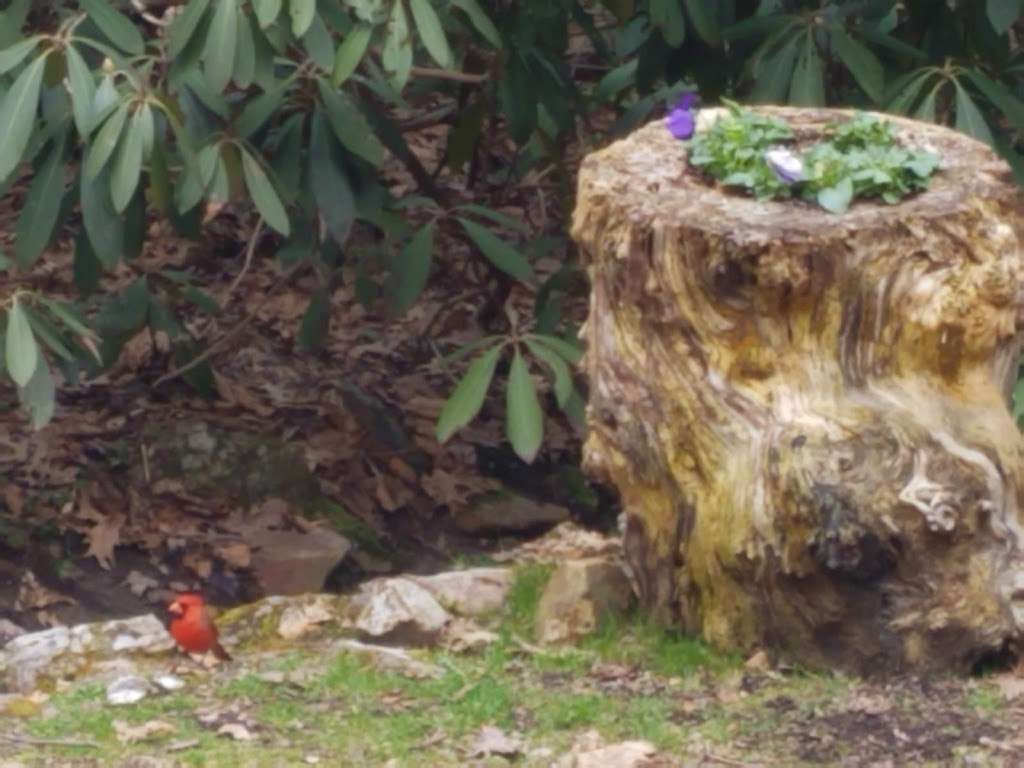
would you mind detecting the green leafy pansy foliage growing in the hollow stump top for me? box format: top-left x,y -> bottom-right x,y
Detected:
688,102 -> 939,213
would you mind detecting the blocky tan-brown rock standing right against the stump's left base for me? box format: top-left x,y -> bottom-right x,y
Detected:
536,557 -> 633,643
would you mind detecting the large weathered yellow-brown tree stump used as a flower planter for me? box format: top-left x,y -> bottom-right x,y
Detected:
573,108 -> 1024,673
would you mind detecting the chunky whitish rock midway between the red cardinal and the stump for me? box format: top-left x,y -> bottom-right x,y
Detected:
351,578 -> 452,645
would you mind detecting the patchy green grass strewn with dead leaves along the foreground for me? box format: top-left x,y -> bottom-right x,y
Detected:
0,565 -> 790,768
